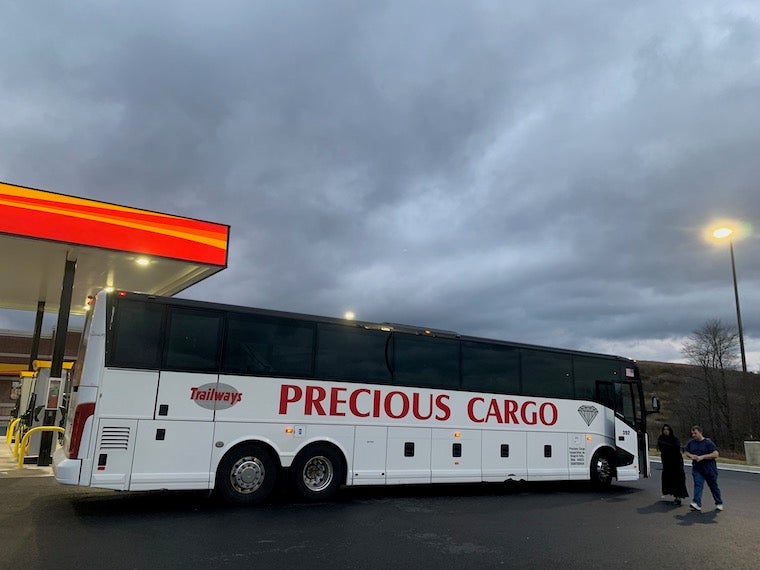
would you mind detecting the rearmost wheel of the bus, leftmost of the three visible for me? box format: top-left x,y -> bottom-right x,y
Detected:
216,444 -> 277,505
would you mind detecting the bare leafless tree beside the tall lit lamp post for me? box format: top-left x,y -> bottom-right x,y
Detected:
681,319 -> 739,443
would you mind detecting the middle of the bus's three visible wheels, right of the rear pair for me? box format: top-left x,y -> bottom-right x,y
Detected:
291,445 -> 345,501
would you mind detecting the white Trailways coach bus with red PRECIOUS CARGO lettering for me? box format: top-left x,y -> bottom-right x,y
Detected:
53,291 -> 649,504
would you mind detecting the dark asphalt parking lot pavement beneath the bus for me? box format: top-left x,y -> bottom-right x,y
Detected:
0,444 -> 760,568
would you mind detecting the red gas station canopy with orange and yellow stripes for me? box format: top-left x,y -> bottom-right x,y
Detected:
0,182 -> 229,314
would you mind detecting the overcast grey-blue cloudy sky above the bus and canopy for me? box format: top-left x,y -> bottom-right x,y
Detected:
0,0 -> 760,370
